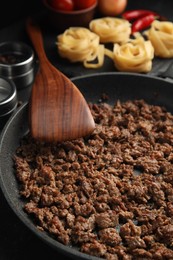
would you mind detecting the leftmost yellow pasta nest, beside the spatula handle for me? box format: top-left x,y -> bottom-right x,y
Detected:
57,27 -> 104,68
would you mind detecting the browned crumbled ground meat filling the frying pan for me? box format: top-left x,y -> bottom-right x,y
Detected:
14,100 -> 173,260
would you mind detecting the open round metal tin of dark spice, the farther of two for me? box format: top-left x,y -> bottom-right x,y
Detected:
0,41 -> 35,89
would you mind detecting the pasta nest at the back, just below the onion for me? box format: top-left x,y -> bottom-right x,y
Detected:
89,17 -> 131,43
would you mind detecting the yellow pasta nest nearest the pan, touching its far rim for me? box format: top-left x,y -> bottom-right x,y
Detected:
113,37 -> 154,72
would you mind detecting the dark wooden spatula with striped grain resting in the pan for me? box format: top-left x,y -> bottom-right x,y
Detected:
26,18 -> 95,142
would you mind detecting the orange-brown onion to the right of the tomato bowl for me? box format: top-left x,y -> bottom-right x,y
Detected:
98,0 -> 127,16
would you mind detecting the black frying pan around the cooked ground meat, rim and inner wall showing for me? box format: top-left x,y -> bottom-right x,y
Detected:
0,72 -> 173,260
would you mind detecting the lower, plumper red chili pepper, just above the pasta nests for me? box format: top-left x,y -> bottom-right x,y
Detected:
132,14 -> 156,34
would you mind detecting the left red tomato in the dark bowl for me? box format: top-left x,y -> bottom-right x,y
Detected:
50,0 -> 74,11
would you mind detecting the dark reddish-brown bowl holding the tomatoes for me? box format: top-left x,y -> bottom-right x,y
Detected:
43,0 -> 98,32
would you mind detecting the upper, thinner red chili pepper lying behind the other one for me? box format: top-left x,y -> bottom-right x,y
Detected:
122,9 -> 159,21
